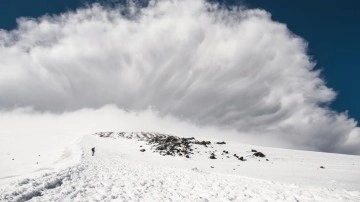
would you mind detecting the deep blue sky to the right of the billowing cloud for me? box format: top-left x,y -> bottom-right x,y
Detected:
240,0 -> 360,124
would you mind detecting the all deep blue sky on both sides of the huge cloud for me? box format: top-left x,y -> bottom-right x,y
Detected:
0,0 -> 360,124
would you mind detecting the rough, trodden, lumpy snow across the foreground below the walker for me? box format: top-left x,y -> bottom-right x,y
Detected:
0,133 -> 360,202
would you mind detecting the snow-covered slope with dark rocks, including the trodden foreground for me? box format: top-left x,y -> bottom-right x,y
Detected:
0,133 -> 360,201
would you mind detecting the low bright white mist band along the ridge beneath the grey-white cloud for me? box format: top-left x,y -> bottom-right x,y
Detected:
0,105 -> 298,156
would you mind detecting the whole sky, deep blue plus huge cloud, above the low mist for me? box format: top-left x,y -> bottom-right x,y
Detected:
0,0 -> 360,154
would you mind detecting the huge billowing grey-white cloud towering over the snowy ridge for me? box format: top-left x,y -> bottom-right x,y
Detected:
0,0 -> 360,154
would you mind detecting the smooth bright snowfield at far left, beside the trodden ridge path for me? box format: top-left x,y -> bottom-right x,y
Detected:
0,132 -> 81,186
